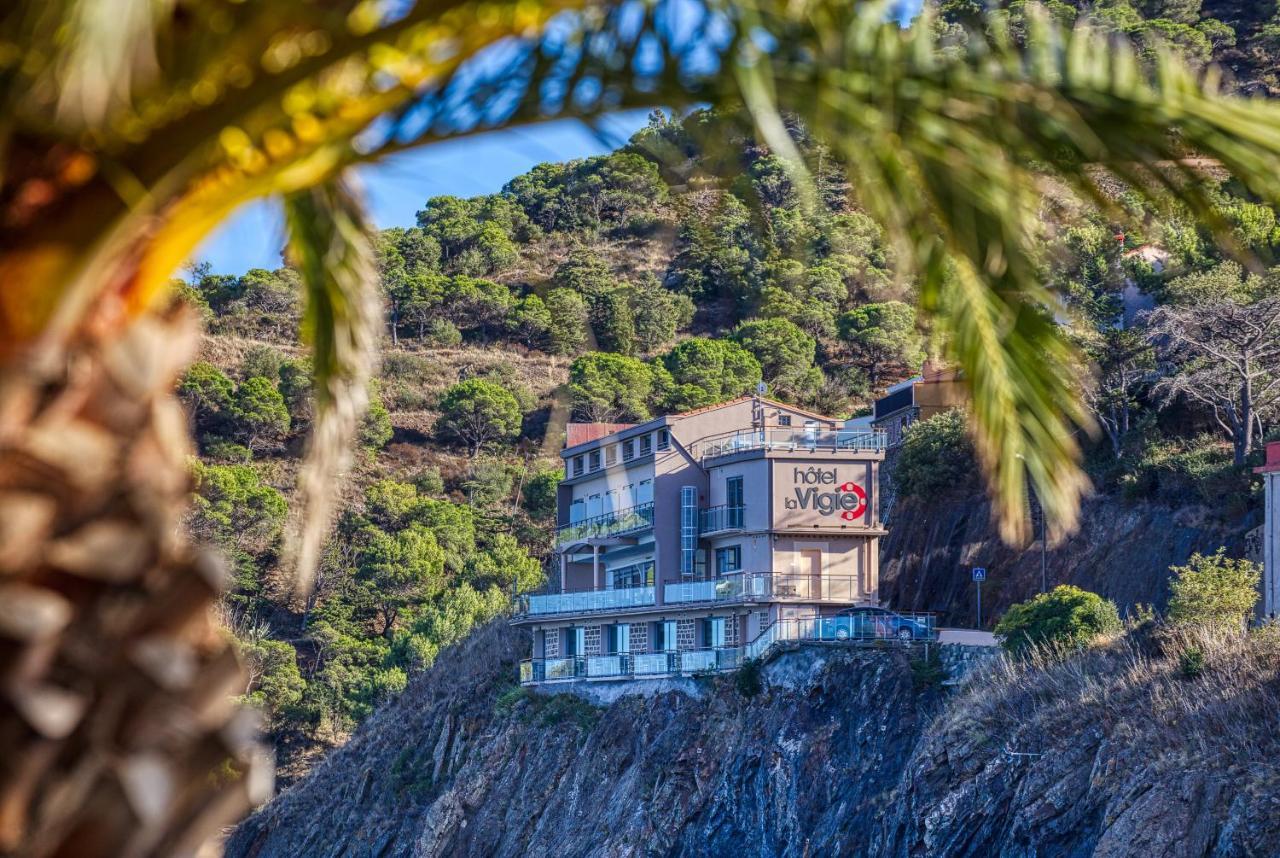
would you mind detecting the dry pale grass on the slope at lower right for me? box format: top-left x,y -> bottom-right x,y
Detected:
937,624 -> 1280,768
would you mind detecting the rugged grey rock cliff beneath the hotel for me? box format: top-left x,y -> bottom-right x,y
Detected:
227,624 -> 1280,858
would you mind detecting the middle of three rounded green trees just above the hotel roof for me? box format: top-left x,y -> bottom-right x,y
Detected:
662,337 -> 760,411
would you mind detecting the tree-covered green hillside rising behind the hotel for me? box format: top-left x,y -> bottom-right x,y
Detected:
179,3 -> 1280,784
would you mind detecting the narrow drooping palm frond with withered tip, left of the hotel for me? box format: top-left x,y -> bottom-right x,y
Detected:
284,179 -> 381,592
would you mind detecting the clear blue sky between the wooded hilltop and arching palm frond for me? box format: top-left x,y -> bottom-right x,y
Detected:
196,110 -> 649,274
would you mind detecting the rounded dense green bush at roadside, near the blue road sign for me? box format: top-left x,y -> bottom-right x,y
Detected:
996,584 -> 1121,656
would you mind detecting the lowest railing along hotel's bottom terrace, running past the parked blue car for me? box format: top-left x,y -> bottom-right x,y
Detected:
520,612 -> 938,684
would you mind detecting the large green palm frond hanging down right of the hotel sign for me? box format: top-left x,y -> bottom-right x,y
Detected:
748,0 -> 1280,542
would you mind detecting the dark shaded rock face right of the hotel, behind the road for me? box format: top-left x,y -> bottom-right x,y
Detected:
881,494 -> 1261,626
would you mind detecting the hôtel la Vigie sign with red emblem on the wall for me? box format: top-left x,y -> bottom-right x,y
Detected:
773,461 -> 868,528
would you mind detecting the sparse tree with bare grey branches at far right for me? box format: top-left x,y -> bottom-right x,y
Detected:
1148,263 -> 1280,466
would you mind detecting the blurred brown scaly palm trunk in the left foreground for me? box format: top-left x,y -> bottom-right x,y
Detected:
0,314 -> 270,858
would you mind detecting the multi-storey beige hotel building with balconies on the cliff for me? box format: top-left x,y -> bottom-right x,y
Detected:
513,397 -> 884,683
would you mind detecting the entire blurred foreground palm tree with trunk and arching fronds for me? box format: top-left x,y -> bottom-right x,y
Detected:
0,0 -> 1280,855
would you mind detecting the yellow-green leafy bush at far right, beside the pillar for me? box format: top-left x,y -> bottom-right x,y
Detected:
1169,548 -> 1262,631
